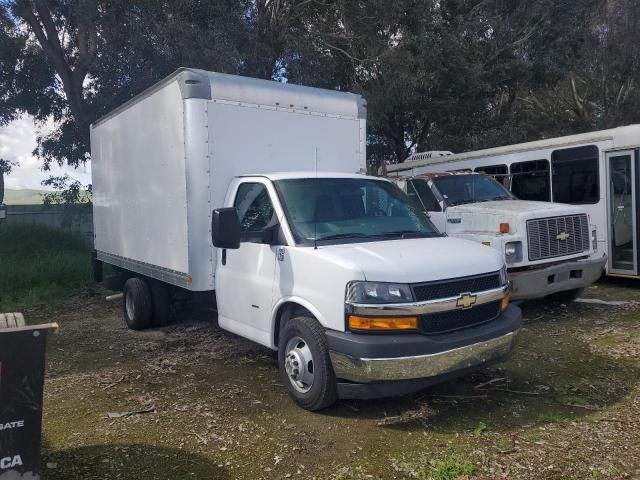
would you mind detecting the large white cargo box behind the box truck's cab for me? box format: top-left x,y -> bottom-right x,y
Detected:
91,69 -> 366,291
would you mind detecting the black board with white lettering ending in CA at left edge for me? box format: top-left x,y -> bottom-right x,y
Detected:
0,324 -> 56,480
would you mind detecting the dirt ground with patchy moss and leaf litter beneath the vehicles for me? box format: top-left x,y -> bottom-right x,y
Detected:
29,282 -> 640,479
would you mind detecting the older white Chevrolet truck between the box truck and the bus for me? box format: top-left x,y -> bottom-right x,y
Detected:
391,171 -> 607,300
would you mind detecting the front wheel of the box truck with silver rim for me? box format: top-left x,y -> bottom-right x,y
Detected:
278,317 -> 338,411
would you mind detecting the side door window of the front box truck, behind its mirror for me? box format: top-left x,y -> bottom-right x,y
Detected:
233,183 -> 275,233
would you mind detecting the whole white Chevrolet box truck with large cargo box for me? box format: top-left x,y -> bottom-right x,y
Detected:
91,69 -> 521,410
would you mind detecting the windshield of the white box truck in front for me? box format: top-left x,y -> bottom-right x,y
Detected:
274,178 -> 440,245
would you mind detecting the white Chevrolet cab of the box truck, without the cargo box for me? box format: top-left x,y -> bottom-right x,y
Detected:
212,172 -> 521,410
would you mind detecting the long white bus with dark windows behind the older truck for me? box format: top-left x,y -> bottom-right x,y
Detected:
387,125 -> 640,277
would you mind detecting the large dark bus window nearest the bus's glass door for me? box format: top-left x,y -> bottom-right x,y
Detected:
551,145 -> 600,204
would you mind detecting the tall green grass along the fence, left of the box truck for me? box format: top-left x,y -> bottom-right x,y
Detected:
0,225 -> 92,312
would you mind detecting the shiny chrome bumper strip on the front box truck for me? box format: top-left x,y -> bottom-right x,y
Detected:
330,331 -> 518,383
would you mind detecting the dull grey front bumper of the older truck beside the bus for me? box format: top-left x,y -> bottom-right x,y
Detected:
508,255 -> 607,300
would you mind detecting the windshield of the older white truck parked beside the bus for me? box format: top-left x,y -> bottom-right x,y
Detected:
433,174 -> 515,205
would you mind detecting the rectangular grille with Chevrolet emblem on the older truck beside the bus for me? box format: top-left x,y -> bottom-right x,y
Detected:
527,214 -> 591,261
